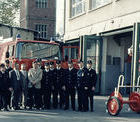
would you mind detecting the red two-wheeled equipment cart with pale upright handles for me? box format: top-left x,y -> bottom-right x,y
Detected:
107,75 -> 140,116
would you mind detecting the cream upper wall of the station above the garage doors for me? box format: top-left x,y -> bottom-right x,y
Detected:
65,0 -> 140,40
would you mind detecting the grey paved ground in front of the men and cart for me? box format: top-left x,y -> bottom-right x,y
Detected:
0,96 -> 140,122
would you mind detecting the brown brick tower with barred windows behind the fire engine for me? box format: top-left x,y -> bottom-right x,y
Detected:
20,0 -> 56,39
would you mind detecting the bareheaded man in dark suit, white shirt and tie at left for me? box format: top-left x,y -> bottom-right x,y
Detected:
9,63 -> 23,110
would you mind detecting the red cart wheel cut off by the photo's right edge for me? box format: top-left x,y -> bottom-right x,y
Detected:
129,92 -> 140,112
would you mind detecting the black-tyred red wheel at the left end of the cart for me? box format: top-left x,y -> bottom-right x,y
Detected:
107,96 -> 122,116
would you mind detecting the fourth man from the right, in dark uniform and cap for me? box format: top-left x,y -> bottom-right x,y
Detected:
53,60 -> 65,108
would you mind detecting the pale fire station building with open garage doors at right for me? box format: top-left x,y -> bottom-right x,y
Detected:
64,0 -> 140,94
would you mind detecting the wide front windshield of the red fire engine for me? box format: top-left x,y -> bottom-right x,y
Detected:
16,42 -> 60,59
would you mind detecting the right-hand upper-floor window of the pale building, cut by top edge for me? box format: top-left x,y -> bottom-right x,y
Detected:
90,0 -> 112,9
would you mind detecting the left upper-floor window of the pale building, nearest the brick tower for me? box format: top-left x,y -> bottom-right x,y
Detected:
71,0 -> 85,17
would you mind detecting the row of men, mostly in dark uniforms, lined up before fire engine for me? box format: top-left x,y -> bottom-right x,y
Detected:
0,60 -> 97,111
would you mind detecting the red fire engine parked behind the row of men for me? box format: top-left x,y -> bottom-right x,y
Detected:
0,38 -> 79,70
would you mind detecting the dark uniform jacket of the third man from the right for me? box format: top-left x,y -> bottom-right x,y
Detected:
64,68 -> 77,89
